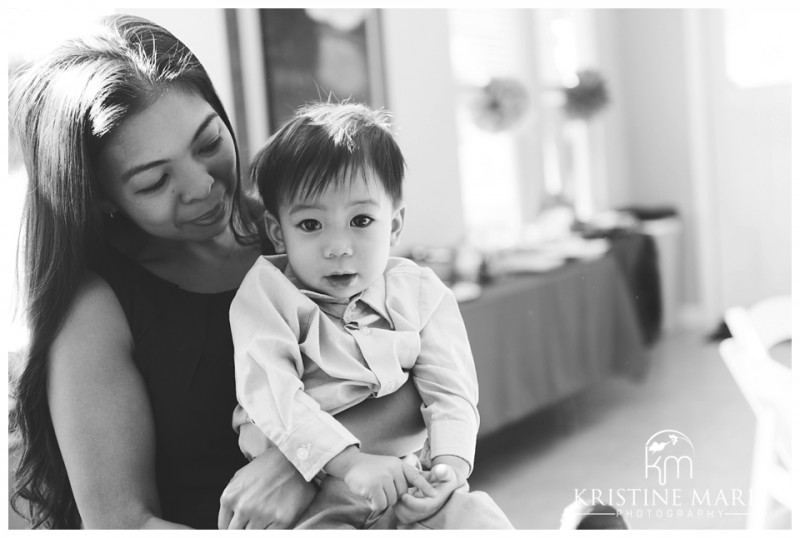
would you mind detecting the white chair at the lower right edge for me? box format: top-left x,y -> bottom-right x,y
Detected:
720,297 -> 792,529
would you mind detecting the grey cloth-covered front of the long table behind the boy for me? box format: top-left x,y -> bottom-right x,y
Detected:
460,253 -> 649,436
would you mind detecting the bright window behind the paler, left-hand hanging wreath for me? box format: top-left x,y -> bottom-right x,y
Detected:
449,9 -> 540,248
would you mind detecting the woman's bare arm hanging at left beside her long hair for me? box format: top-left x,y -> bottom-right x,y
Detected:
47,275 -> 186,528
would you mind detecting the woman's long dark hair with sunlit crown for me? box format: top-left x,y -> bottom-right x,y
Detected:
9,15 -> 257,529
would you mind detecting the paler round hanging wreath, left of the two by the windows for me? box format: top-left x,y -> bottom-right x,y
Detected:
471,77 -> 529,133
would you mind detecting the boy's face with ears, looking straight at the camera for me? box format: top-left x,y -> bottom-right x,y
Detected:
267,170 -> 405,299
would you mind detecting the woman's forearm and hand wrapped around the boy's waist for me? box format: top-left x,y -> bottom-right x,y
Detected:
219,381 -> 426,529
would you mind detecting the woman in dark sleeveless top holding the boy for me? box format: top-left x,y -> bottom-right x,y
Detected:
10,16 -> 424,528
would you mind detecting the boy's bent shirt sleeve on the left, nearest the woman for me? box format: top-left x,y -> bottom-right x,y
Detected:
230,259 -> 358,480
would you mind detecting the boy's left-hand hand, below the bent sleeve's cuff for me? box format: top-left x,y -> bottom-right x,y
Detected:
326,451 -> 436,512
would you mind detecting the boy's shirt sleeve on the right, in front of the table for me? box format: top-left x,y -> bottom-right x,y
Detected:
412,270 -> 480,471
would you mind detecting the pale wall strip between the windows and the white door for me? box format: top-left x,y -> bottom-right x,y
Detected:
611,9 -> 699,304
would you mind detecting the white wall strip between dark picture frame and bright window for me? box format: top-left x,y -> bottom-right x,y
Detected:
381,9 -> 464,250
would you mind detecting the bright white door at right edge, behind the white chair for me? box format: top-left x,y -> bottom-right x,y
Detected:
687,10 -> 794,316
